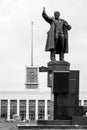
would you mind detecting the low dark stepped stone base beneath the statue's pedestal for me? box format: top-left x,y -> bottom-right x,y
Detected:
17,116 -> 87,130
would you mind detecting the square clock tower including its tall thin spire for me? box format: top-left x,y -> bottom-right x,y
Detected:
25,22 -> 39,90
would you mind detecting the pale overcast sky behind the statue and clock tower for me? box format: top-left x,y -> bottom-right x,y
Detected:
0,0 -> 87,95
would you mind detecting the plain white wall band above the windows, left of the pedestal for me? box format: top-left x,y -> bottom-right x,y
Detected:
0,91 -> 51,100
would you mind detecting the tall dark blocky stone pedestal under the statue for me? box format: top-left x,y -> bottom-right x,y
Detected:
48,61 -> 82,120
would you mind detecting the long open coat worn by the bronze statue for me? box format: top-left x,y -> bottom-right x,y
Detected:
42,10 -> 70,54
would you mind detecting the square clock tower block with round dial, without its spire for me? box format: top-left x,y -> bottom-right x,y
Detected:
25,66 -> 39,89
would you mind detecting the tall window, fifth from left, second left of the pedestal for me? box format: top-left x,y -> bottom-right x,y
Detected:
38,100 -> 45,120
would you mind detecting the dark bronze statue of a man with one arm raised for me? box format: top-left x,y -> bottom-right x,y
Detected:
42,8 -> 71,61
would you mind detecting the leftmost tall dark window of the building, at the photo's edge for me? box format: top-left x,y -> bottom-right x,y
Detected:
1,100 -> 8,119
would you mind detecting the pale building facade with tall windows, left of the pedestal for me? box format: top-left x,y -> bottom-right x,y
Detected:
0,91 -> 50,121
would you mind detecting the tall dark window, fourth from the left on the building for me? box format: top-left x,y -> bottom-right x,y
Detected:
29,100 -> 36,121
